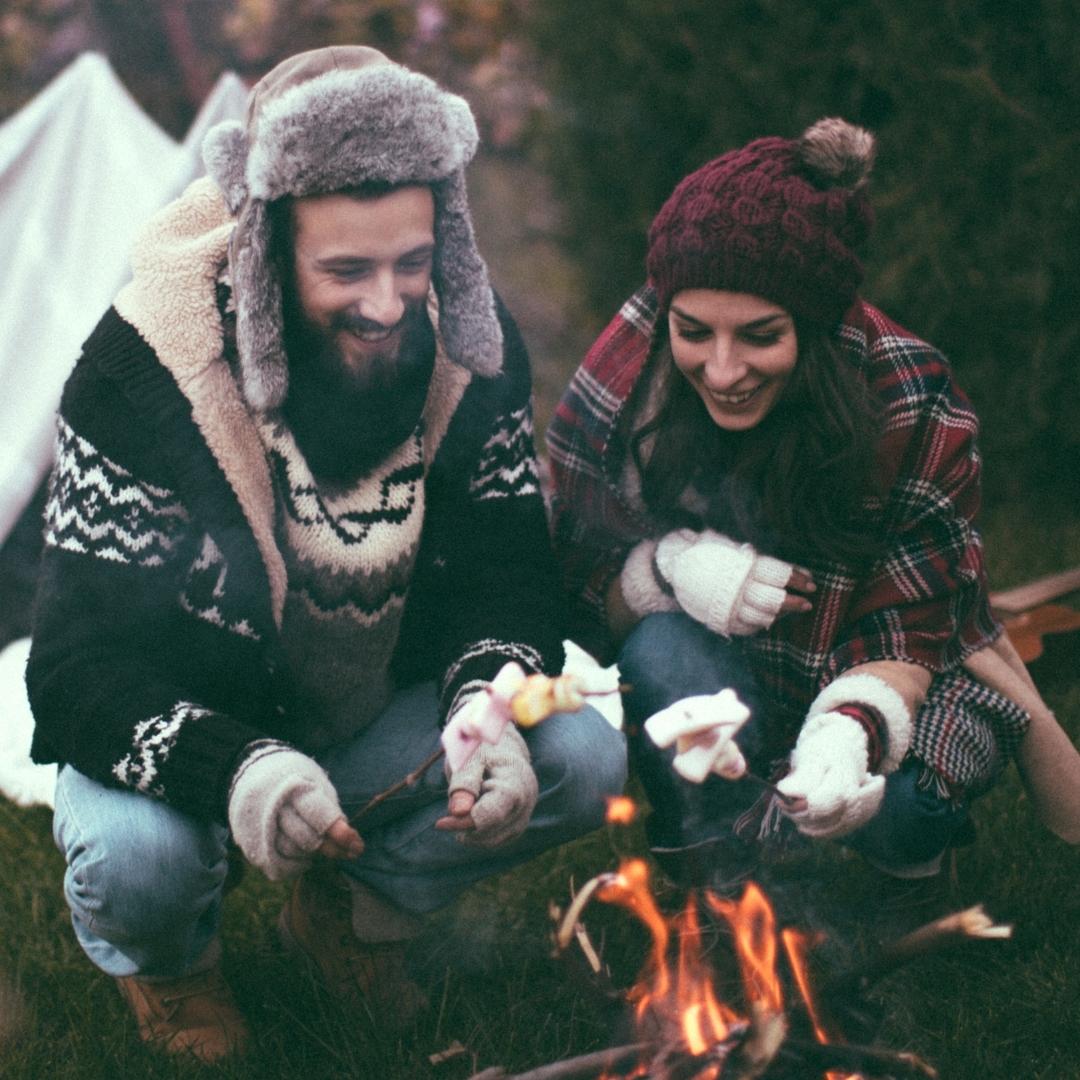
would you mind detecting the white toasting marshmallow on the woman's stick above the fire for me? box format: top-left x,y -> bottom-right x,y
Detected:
645,689 -> 750,784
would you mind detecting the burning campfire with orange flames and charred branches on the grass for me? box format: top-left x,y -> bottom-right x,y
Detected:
473,799 -> 1011,1080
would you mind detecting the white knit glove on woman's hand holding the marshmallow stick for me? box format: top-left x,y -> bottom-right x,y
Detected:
777,713 -> 885,838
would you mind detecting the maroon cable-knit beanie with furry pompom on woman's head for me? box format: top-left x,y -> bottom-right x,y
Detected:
647,119 -> 874,327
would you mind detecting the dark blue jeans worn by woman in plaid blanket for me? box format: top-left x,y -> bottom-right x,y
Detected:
619,612 -> 967,881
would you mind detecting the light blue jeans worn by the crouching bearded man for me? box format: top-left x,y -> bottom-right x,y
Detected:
53,684 -> 626,977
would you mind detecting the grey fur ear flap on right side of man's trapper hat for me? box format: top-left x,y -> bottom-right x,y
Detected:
432,170 -> 502,376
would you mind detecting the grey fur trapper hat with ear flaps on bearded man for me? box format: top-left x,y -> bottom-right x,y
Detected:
203,45 -> 502,409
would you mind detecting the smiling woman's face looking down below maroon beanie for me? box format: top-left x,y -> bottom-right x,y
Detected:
667,288 -> 798,431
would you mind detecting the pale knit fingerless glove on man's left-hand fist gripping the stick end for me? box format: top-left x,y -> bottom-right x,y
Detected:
229,742 -> 342,881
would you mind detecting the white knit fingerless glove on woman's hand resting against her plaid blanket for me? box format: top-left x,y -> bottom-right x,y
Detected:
656,529 -> 793,636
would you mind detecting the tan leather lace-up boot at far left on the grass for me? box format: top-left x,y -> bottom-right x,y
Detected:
117,962 -> 248,1065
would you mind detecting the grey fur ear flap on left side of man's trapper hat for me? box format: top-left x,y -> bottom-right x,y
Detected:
229,199 -> 288,411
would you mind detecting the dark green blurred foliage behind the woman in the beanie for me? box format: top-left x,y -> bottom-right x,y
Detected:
529,0 -> 1080,505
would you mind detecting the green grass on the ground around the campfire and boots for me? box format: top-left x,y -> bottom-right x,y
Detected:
0,468 -> 1080,1080
